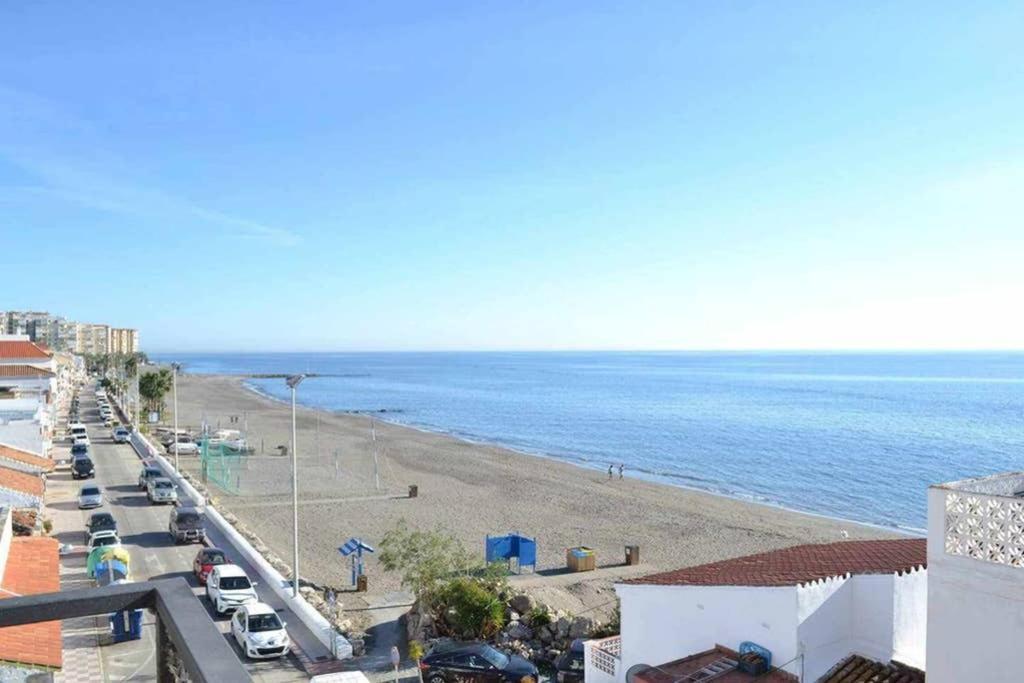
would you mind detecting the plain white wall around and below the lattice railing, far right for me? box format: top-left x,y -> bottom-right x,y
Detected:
927,487 -> 1024,683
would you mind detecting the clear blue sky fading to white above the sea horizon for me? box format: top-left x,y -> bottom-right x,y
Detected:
0,1 -> 1024,350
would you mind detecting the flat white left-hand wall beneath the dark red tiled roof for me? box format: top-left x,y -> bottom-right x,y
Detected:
615,584 -> 798,680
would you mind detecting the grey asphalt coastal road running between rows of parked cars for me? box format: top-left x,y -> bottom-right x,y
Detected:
78,390 -> 309,683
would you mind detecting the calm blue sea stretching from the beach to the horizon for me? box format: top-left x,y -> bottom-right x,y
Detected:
151,352 -> 1024,528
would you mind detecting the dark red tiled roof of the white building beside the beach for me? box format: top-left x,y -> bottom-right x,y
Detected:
623,539 -> 928,586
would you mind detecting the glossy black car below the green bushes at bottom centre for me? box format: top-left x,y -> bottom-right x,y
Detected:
420,643 -> 540,683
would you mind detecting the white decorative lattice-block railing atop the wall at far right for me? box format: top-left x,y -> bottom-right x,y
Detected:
944,490 -> 1024,567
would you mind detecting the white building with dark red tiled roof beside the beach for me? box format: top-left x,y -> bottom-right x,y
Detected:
587,539 -> 928,683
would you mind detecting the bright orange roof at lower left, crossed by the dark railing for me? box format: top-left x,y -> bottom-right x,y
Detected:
0,537 -> 61,669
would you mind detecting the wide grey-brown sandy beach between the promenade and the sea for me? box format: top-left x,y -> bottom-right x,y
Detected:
168,375 -> 895,592
